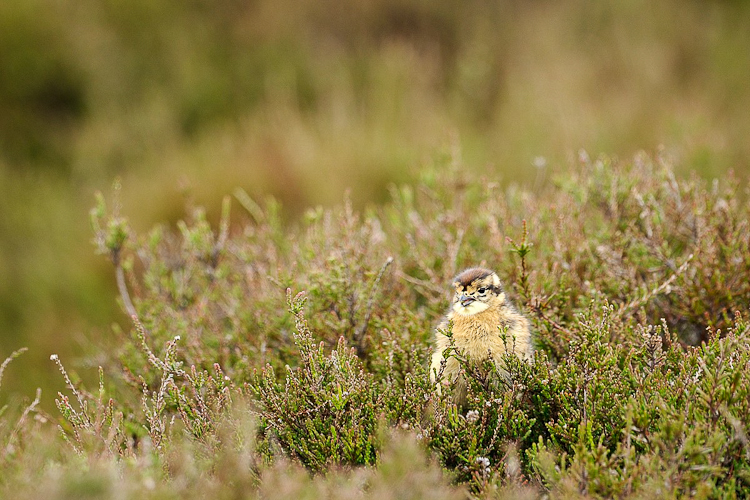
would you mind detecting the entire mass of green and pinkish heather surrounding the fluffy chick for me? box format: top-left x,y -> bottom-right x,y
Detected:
3,156 -> 750,498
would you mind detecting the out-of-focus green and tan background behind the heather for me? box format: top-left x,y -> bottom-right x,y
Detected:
0,0 -> 750,401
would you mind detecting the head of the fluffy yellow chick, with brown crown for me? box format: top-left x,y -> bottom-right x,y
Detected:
452,267 -> 505,316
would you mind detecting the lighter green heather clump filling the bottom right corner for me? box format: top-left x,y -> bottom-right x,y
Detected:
532,316 -> 750,498
